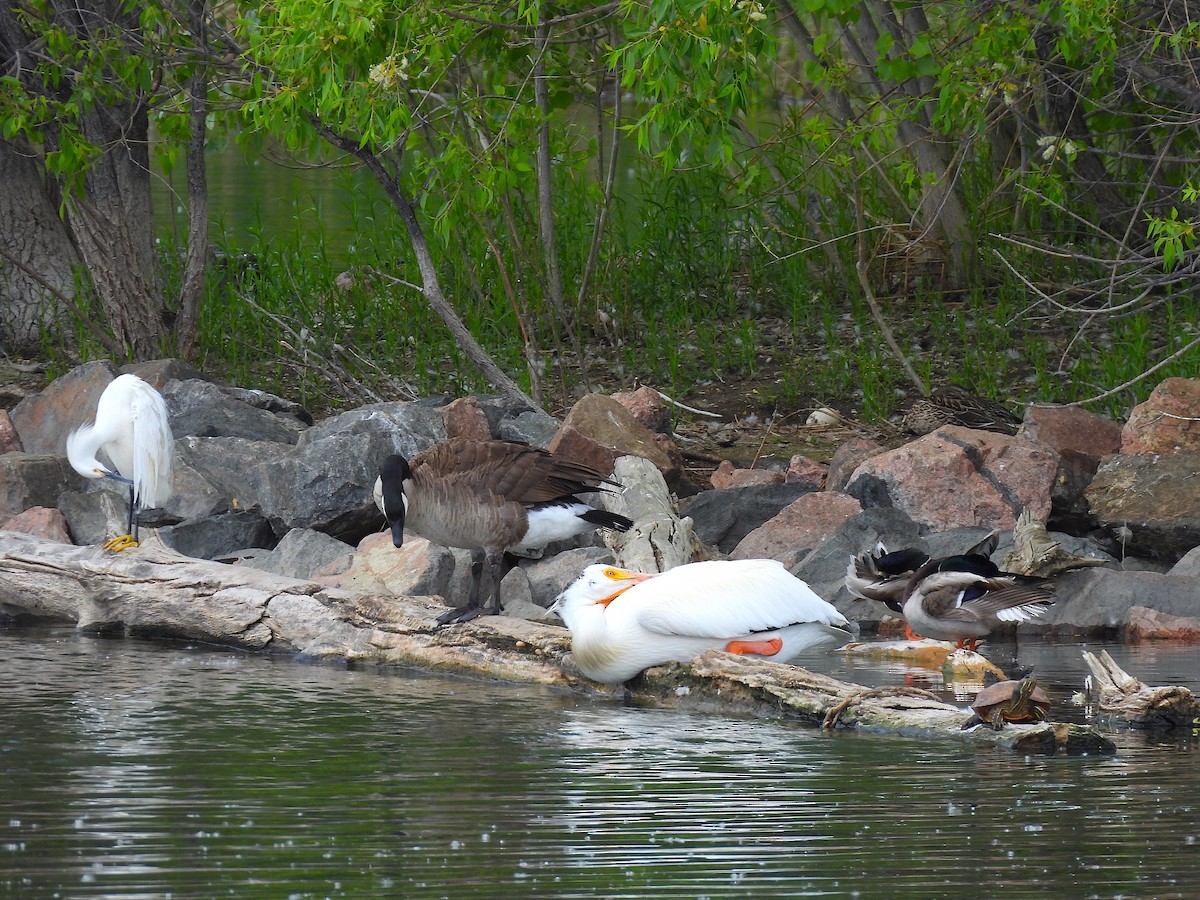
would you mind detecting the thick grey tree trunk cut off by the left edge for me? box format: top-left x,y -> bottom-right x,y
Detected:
0,142 -> 79,353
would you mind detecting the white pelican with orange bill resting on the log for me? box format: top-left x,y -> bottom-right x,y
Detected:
550,559 -> 850,684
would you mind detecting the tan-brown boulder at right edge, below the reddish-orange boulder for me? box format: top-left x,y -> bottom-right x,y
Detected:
1087,450 -> 1200,563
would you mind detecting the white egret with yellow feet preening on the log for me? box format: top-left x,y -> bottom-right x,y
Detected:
67,374 -> 175,551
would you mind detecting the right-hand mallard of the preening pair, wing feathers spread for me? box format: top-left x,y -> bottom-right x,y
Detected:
904,557 -> 1054,650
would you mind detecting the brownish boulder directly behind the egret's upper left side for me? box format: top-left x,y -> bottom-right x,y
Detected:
10,360 -> 118,456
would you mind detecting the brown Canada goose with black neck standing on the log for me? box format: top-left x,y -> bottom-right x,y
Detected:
374,439 -> 634,624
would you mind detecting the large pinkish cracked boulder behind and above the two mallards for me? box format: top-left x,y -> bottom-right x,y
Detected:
846,425 -> 1058,530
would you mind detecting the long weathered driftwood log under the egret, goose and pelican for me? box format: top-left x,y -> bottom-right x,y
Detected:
0,532 -> 1115,754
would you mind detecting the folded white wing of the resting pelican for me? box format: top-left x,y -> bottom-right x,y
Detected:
608,559 -> 847,638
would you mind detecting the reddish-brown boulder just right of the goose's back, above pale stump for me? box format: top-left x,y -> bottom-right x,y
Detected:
547,394 -> 683,485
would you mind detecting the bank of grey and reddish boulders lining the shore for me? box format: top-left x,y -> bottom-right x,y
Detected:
0,360 -> 1200,641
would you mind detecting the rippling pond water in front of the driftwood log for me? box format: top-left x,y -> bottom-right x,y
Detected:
0,628 -> 1200,898
